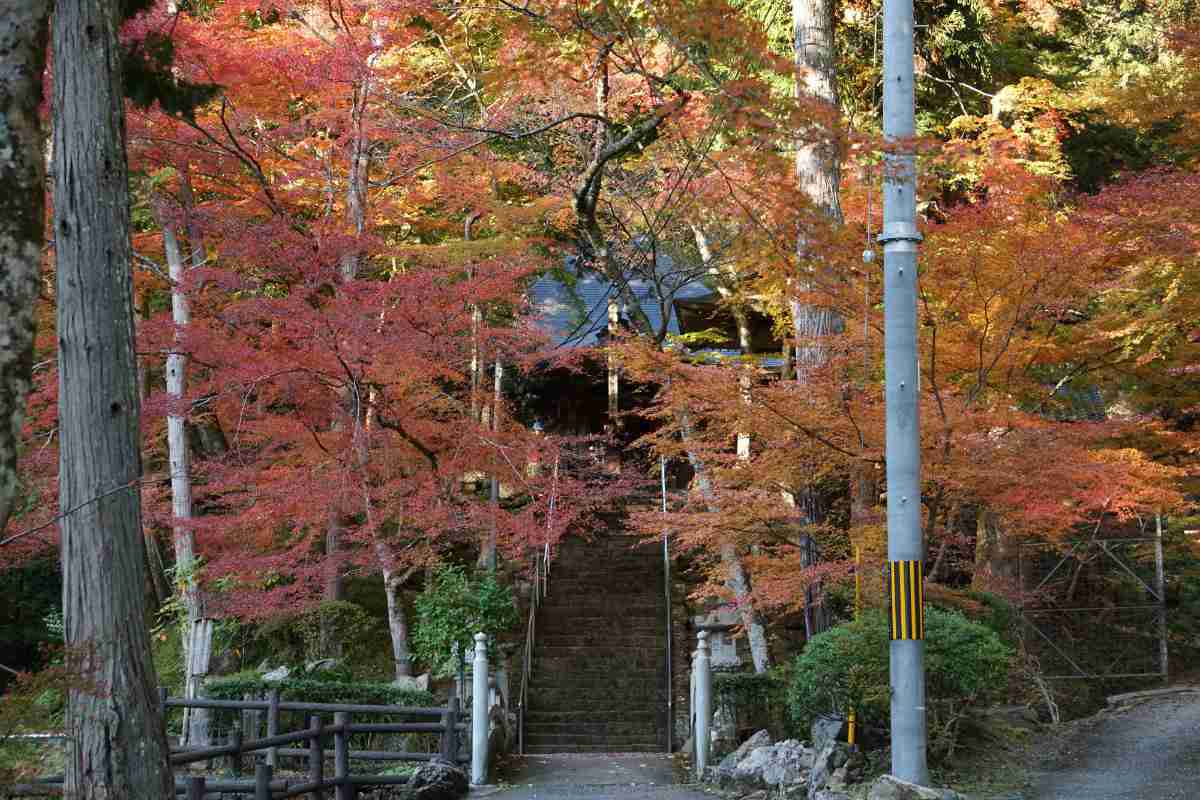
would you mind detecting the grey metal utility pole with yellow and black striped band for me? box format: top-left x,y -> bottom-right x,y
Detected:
880,0 -> 929,784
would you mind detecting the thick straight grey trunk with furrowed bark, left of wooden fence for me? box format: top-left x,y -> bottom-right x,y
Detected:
54,0 -> 175,800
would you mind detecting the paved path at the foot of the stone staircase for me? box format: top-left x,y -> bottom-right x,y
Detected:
470,753 -> 713,800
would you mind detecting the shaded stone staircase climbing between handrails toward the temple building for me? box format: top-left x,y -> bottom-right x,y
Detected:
526,534 -> 667,753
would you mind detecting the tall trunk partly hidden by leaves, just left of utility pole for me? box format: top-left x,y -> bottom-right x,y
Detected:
791,0 -> 842,636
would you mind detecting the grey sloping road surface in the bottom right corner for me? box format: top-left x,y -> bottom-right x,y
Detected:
1026,693 -> 1200,800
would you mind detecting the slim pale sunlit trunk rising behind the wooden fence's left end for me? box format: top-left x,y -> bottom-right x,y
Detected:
158,215 -> 212,745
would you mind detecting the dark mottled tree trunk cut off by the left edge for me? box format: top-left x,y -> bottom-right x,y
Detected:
0,0 -> 50,531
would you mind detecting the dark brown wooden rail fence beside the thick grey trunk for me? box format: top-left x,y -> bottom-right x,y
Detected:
0,692 -> 467,800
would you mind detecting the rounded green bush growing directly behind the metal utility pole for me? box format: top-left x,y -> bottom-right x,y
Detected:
787,608 -> 1013,758
